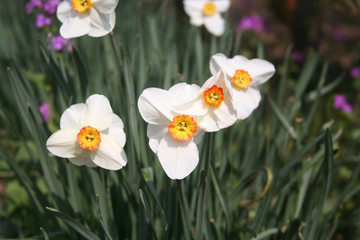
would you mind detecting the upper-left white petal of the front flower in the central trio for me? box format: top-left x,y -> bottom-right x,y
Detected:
138,88 -> 173,126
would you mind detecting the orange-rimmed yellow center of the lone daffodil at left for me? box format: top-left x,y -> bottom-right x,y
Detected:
76,126 -> 101,150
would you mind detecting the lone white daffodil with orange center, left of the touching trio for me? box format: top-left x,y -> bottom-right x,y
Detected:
46,94 -> 127,170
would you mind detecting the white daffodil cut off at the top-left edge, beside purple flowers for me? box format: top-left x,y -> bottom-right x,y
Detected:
56,0 -> 118,39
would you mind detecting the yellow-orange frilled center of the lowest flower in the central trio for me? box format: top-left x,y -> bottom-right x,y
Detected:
168,115 -> 197,141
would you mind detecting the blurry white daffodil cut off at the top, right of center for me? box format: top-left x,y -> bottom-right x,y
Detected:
184,0 -> 230,36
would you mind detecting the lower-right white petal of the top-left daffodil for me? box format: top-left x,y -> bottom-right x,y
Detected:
88,8 -> 116,37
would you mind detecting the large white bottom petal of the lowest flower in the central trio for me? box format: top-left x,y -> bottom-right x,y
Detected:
158,134 -> 199,179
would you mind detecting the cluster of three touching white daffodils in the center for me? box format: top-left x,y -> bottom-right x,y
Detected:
138,53 -> 275,179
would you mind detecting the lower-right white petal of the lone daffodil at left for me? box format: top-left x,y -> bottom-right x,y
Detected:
91,134 -> 127,170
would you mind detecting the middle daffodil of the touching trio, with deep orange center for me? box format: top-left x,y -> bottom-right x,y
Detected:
173,71 -> 237,132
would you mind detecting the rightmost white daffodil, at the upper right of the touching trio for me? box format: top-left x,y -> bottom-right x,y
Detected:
210,53 -> 275,119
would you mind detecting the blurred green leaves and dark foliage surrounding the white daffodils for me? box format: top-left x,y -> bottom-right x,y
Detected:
0,0 -> 360,240
